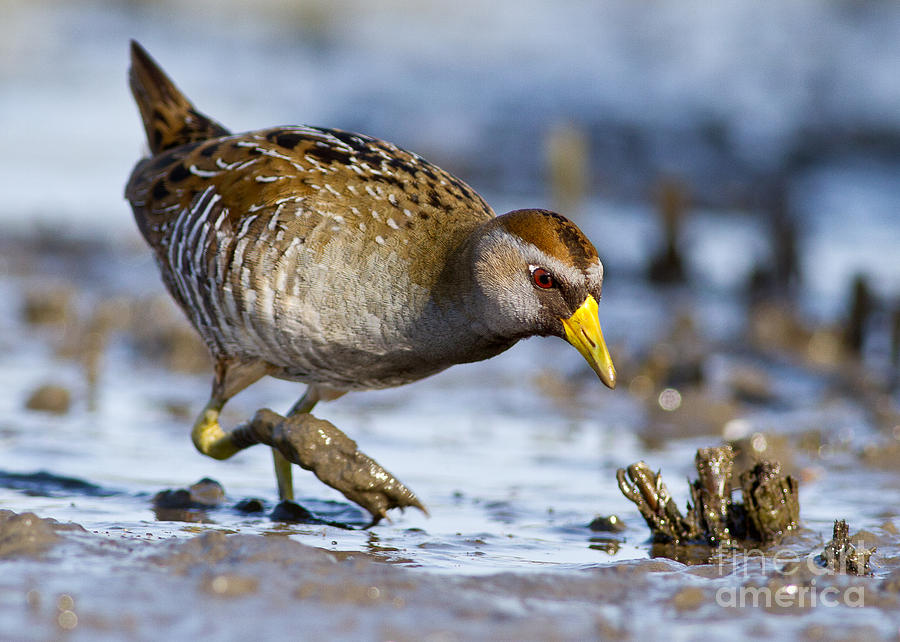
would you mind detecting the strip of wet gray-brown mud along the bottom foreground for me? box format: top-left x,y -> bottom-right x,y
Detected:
0,515 -> 900,640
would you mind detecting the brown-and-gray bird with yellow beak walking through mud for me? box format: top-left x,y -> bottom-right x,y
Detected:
125,40 -> 616,523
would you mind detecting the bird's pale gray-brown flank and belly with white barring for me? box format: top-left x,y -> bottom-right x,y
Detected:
163,190 -> 449,388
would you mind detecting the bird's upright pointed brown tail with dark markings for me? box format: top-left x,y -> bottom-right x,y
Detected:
128,40 -> 230,155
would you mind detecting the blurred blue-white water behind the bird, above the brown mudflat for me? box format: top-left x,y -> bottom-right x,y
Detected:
0,0 -> 900,318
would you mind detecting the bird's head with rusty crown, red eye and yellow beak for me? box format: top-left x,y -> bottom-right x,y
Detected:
460,210 -> 616,388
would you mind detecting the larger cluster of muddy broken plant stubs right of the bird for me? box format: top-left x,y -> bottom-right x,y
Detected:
616,446 -> 800,547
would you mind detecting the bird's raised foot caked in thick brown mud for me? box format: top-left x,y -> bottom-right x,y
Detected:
245,409 -> 428,524
